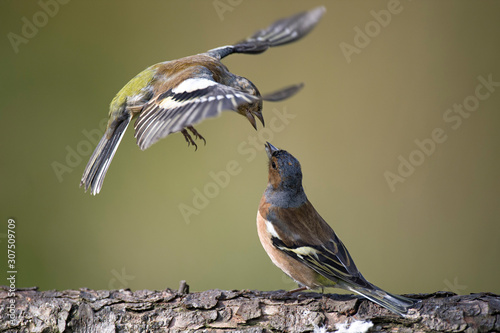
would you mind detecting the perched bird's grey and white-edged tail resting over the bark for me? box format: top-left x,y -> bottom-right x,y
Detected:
343,284 -> 419,317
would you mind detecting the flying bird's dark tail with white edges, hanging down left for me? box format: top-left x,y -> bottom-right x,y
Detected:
80,116 -> 131,195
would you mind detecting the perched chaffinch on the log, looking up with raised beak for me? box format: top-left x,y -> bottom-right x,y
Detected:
257,142 -> 417,316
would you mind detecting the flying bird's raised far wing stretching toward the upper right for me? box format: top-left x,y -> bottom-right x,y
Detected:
207,7 -> 326,59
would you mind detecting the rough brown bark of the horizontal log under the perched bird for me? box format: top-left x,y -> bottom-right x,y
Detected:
0,285 -> 500,333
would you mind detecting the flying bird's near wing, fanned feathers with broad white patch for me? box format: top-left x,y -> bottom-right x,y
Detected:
134,73 -> 260,150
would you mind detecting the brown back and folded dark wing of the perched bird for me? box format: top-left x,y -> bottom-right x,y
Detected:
271,202 -> 371,288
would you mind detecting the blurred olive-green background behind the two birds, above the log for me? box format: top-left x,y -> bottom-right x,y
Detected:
0,0 -> 500,293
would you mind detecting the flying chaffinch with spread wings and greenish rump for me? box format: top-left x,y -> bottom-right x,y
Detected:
80,7 -> 325,195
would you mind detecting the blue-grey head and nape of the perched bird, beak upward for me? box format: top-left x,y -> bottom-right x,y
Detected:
265,142 -> 307,207
